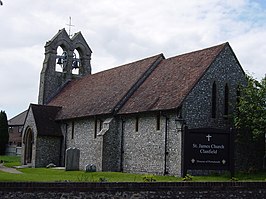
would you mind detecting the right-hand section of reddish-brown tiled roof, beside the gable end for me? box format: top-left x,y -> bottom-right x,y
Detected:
119,43 -> 227,114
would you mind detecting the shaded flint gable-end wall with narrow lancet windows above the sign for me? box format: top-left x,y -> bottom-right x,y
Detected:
182,47 -> 246,128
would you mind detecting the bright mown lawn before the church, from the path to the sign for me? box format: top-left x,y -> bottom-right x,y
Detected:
0,168 -> 181,182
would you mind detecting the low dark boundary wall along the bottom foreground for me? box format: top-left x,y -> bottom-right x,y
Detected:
0,182 -> 266,199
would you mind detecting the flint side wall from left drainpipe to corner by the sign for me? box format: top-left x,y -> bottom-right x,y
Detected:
123,113 -> 181,175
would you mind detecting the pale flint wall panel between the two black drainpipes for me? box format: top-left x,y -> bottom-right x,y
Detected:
123,115 -> 165,174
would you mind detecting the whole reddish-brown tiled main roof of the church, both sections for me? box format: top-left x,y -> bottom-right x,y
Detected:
48,43 -> 228,120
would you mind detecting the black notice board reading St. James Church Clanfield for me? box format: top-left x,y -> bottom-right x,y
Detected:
185,129 -> 233,170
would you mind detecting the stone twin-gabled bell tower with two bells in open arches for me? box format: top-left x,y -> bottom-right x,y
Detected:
38,29 -> 92,104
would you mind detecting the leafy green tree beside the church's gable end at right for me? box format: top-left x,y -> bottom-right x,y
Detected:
234,76 -> 266,170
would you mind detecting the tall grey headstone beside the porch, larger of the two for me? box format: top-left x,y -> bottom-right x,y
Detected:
65,147 -> 80,171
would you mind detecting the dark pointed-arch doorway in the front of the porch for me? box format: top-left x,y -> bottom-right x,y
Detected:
24,128 -> 33,164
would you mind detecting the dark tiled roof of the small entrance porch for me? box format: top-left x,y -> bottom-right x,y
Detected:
30,104 -> 62,136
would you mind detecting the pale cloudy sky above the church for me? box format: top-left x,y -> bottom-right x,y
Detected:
0,0 -> 266,119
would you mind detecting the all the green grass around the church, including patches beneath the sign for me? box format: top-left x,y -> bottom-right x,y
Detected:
0,156 -> 266,182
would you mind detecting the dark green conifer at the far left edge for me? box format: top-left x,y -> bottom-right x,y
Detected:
0,111 -> 9,155
